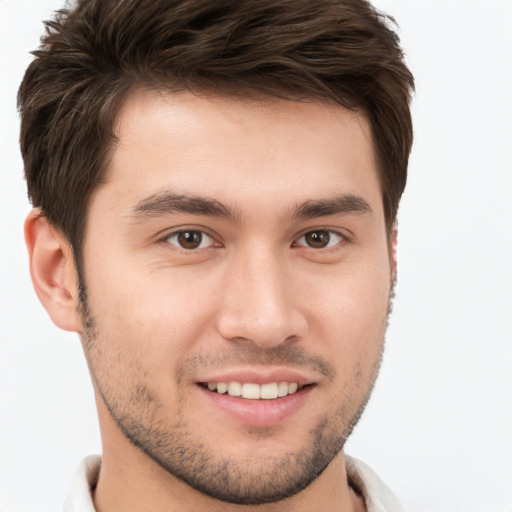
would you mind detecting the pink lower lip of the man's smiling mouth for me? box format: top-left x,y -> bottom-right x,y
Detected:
197,385 -> 314,427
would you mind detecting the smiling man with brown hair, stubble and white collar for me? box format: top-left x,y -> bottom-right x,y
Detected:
19,0 -> 413,512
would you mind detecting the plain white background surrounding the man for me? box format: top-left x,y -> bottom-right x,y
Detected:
0,0 -> 512,512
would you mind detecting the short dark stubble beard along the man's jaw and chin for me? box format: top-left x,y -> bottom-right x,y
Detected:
80,286 -> 394,505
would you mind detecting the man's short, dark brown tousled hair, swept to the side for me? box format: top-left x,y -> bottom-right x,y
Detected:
18,0 -> 414,259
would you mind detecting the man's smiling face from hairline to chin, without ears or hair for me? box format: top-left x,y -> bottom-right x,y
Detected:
82,92 -> 393,503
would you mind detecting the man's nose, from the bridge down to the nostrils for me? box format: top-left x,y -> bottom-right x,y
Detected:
217,248 -> 308,349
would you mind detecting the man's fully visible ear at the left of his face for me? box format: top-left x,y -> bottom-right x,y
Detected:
25,209 -> 82,333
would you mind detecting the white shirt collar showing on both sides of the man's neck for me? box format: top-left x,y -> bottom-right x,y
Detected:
63,455 -> 403,512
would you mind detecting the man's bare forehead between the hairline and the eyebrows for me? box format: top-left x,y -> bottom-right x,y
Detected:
100,86 -> 381,218
